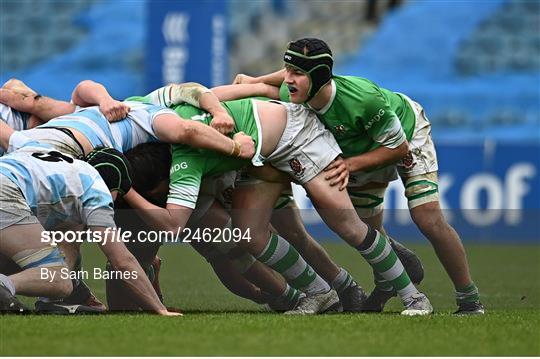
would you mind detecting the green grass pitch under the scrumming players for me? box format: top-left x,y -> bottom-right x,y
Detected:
0,244 -> 540,356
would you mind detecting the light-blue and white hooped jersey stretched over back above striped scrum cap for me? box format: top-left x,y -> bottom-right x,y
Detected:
39,101 -> 176,152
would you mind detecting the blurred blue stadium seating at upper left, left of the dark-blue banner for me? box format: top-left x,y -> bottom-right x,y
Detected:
0,0 -> 146,100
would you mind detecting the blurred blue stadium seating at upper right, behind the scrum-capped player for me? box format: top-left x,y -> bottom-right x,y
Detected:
336,0 -> 540,142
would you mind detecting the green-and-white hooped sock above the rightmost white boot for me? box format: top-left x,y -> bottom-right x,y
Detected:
357,228 -> 418,302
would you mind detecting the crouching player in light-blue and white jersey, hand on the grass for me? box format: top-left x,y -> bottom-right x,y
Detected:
0,129 -> 177,316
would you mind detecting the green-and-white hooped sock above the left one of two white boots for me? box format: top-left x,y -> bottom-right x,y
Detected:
257,233 -> 330,294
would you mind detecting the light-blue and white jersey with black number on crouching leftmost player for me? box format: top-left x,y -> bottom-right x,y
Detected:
0,142 -> 115,229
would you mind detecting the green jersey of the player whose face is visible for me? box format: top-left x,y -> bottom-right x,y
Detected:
280,76 -> 416,157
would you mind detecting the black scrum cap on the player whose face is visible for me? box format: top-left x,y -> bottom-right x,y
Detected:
283,38 -> 334,101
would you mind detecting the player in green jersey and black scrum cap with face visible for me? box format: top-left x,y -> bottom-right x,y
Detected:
235,38 -> 484,314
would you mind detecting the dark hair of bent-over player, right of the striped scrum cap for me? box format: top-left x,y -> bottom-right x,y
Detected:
126,143 -> 172,194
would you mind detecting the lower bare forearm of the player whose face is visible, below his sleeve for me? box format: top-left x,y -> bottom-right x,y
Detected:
345,141 -> 409,172
